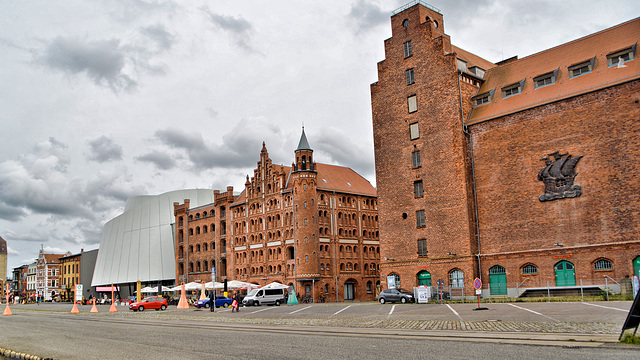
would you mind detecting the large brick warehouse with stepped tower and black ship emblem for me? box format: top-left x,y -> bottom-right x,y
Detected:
371,1 -> 640,296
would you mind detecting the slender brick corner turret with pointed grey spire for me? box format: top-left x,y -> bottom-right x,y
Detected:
291,128 -> 320,295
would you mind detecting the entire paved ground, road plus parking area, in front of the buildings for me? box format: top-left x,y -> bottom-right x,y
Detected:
0,302 -> 640,360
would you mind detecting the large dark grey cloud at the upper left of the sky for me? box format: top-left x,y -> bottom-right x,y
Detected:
43,37 -> 136,90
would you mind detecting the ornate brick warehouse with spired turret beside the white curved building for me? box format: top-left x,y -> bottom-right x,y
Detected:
174,130 -> 380,301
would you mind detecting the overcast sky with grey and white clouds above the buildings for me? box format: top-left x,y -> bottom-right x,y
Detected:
0,0 -> 640,274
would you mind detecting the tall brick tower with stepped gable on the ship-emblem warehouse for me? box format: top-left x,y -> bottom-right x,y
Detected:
371,1 -> 478,288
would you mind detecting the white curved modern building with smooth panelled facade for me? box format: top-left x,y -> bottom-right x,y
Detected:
91,189 -> 214,286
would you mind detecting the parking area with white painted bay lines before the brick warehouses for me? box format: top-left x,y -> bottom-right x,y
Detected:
7,301 -> 632,326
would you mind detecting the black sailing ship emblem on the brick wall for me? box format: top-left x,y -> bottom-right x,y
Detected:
538,151 -> 582,201
